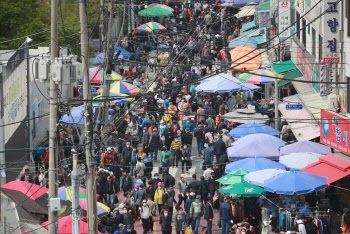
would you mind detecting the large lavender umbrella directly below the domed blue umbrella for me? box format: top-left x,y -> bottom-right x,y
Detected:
227,141 -> 279,160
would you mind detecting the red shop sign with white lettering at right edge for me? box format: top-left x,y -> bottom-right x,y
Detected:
321,109 -> 350,155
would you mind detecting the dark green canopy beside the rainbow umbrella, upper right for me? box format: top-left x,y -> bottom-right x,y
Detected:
271,60 -> 303,87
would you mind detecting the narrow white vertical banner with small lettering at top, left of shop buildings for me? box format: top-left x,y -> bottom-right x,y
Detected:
278,0 -> 291,38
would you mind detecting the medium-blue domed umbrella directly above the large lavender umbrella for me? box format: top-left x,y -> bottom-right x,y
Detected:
228,123 -> 281,138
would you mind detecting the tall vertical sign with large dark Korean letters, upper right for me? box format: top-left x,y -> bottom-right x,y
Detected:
323,0 -> 341,62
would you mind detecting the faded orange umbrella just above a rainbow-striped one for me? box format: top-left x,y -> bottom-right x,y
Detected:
230,45 -> 262,71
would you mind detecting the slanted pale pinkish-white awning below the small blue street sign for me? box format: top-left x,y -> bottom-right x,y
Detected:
278,95 -> 320,141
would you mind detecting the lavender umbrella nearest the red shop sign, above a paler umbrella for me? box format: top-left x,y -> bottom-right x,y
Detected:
280,141 -> 332,155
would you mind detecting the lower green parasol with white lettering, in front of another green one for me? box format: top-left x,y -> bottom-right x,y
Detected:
219,181 -> 266,197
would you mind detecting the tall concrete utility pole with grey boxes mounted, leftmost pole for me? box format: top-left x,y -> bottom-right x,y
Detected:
48,0 -> 58,234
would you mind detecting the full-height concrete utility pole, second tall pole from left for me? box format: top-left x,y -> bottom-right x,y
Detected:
79,0 -> 97,233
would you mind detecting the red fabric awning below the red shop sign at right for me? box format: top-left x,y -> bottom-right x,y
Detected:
302,154 -> 350,184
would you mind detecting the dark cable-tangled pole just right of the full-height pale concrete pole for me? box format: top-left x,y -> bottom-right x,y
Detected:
102,0 -> 114,135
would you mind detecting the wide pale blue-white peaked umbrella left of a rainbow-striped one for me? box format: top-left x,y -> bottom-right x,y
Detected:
196,73 -> 260,93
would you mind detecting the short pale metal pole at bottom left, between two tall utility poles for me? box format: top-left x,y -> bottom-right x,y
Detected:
72,154 -> 80,234
